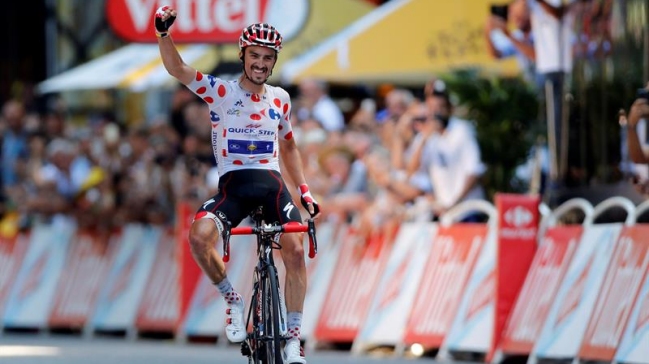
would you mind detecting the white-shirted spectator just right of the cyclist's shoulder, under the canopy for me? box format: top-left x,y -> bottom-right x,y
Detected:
297,79 -> 345,132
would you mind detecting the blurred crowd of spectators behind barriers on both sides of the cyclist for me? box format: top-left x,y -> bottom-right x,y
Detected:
0,74 -> 481,242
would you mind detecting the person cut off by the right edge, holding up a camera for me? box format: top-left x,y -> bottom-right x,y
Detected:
626,83 -> 649,195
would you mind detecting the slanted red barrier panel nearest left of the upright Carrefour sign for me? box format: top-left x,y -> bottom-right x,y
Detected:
404,224 -> 487,348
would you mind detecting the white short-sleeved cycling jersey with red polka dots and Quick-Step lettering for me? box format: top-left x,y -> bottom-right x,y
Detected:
187,71 -> 293,176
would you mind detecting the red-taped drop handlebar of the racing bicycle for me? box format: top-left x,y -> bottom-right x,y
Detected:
223,219 -> 318,263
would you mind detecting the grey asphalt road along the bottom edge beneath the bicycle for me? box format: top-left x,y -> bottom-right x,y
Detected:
0,333 -> 478,364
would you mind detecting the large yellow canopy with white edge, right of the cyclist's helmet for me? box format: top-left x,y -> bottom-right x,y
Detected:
283,0 -> 519,83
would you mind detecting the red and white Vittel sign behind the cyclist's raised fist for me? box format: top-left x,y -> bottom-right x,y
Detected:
106,0 -> 309,43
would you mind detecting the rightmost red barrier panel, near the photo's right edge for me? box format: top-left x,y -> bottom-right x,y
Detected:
579,225 -> 649,361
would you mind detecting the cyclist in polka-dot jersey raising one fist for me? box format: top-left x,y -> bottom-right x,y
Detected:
154,6 -> 320,363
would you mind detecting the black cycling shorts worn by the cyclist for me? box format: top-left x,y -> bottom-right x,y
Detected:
196,169 -> 302,227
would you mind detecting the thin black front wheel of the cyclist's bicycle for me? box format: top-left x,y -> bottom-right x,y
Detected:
258,265 -> 284,364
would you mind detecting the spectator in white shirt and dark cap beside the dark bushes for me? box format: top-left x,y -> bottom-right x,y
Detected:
421,80 -> 484,221
